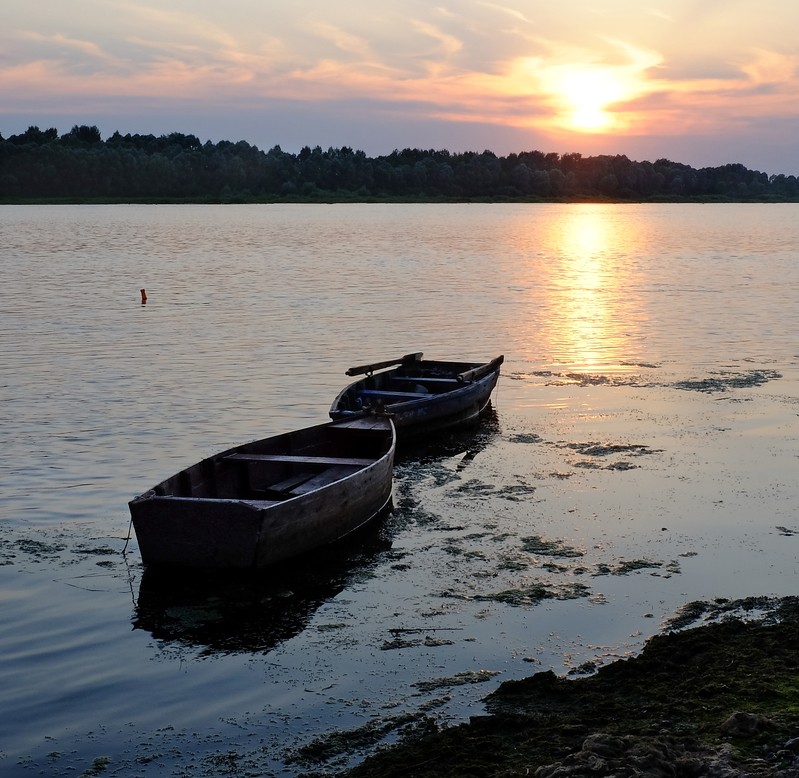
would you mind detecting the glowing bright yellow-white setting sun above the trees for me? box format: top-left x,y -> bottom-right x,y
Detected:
552,68 -> 631,132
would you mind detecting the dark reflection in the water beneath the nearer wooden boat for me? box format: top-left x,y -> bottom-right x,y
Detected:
133,521 -> 391,655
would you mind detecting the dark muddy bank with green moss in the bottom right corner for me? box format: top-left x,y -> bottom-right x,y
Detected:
347,597 -> 799,778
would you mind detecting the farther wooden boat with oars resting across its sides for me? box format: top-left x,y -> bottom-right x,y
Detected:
330,352 -> 504,441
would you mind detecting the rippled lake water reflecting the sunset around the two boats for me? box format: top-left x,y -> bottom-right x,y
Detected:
0,204 -> 799,776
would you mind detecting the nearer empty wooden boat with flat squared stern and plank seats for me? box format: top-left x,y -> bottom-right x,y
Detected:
129,413 -> 396,569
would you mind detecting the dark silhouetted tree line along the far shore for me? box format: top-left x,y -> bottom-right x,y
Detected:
0,125 -> 799,202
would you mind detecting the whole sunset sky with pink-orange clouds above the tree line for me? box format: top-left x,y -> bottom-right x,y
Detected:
0,0 -> 799,175
